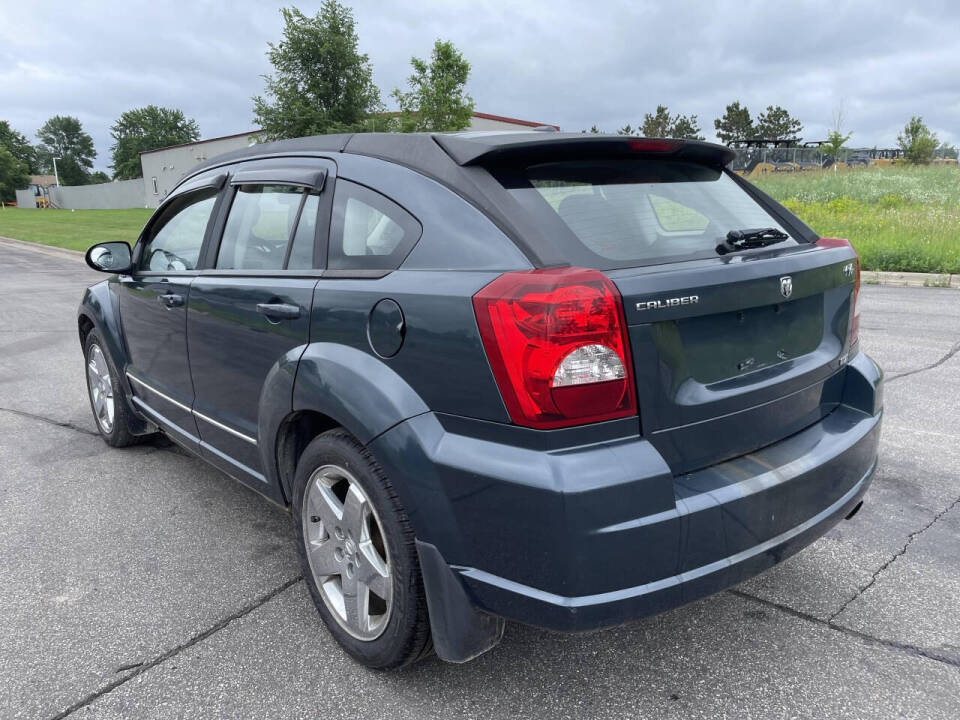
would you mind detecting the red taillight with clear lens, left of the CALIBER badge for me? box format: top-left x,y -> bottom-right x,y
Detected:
473,268 -> 637,429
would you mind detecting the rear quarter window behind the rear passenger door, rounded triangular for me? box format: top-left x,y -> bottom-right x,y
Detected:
327,180 -> 420,270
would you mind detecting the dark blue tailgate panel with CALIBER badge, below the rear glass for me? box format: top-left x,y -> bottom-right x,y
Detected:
609,247 -> 853,472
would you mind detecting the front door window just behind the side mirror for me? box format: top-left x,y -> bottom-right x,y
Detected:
139,190 -> 217,272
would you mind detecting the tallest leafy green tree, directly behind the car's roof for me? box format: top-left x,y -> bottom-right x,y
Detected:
253,0 -> 383,140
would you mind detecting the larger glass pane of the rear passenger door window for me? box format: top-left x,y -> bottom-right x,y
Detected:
216,185 -> 304,270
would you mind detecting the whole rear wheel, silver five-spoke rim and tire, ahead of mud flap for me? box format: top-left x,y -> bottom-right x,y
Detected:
293,430 -> 430,669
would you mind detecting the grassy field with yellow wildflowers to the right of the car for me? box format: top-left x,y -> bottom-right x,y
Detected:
751,166 -> 960,273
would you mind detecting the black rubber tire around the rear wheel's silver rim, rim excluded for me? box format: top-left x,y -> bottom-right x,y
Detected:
292,429 -> 432,670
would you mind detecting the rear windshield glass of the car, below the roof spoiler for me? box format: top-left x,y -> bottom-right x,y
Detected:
493,159 -> 796,270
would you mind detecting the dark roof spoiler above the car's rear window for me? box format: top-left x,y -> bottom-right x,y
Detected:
434,133 -> 736,168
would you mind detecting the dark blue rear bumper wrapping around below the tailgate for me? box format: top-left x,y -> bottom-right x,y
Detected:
372,354 -> 882,631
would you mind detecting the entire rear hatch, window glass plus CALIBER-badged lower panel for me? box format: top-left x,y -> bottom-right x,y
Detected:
491,143 -> 856,473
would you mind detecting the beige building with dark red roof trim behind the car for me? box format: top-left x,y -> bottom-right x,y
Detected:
140,112 -> 560,207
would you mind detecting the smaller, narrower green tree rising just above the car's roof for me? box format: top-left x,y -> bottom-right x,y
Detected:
391,40 -> 473,132
